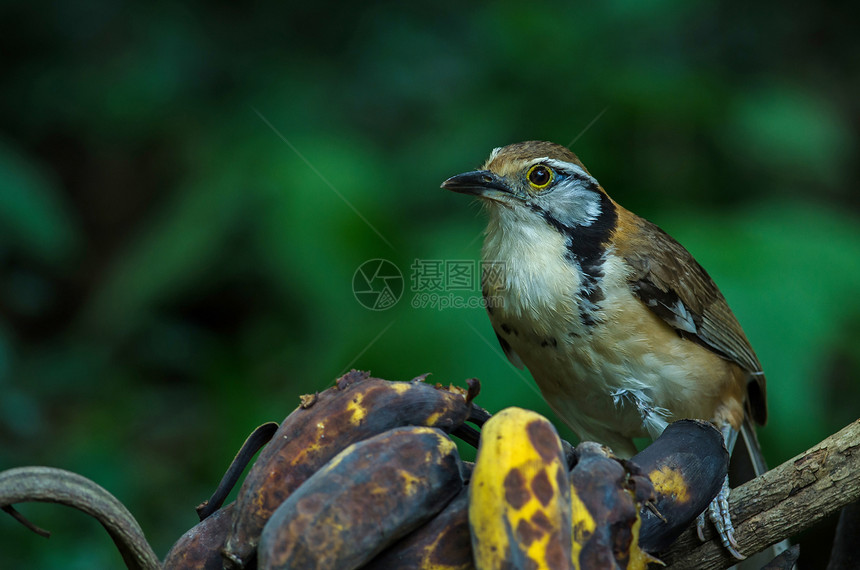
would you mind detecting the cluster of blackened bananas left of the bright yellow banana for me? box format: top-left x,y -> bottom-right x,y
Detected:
164,371 -> 480,570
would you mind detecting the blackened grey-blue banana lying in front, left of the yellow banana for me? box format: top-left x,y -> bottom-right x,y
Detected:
258,427 -> 463,570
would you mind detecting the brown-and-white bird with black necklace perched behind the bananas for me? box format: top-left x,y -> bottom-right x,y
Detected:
442,141 -> 767,559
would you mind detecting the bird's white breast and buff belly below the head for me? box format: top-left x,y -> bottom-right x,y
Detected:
484,236 -> 731,451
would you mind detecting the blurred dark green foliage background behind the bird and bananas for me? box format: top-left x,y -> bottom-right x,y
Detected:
0,0 -> 860,569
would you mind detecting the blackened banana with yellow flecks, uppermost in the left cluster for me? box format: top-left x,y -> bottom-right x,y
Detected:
224,371 -> 479,568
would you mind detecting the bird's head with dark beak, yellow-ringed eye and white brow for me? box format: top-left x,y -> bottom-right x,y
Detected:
442,141 -> 609,228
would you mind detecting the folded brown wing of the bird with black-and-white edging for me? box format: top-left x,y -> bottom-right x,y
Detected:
619,212 -> 767,424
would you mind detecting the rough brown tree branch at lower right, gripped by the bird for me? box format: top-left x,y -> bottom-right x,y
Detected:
660,414 -> 860,570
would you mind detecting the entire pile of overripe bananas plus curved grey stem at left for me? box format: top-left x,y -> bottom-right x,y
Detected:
0,371 -> 728,570
